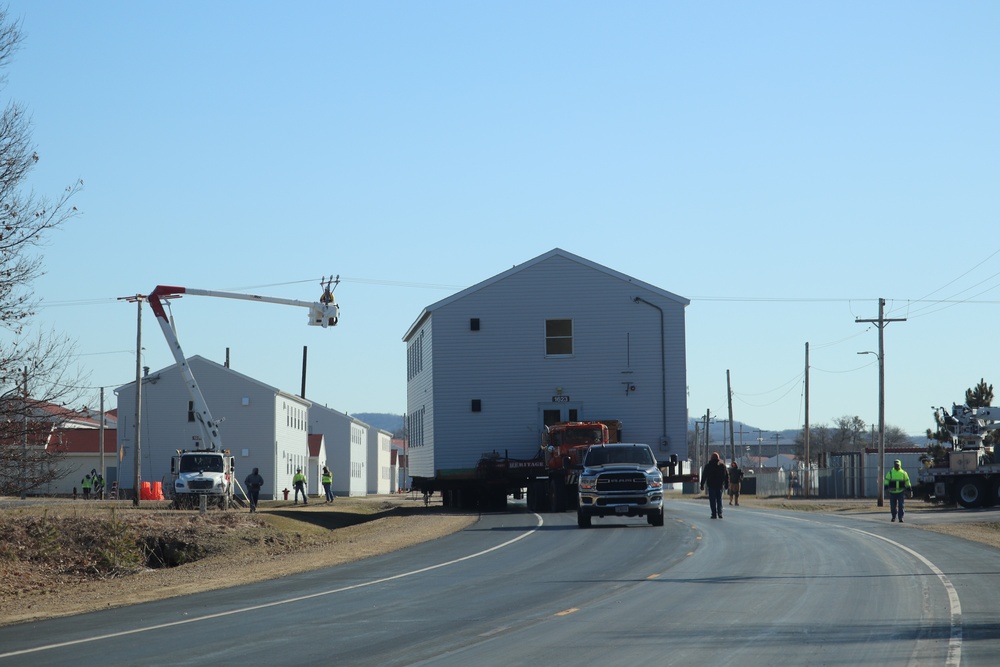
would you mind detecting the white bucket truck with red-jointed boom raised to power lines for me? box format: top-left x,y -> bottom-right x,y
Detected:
147,276 -> 340,509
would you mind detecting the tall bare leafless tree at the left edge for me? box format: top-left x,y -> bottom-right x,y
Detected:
0,8 -> 83,494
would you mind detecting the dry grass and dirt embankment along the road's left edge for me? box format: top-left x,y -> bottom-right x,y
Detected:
0,496 -> 477,625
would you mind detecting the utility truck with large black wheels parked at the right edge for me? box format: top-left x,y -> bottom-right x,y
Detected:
917,405 -> 1000,509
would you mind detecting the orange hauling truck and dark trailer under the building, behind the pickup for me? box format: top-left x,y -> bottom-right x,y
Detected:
413,420 -> 697,512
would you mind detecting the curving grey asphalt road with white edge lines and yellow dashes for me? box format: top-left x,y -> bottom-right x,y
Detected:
0,500 -> 1000,667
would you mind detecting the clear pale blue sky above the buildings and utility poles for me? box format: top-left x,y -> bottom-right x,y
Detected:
4,0 -> 1000,440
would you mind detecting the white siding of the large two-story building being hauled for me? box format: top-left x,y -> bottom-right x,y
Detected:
407,253 -> 687,477
